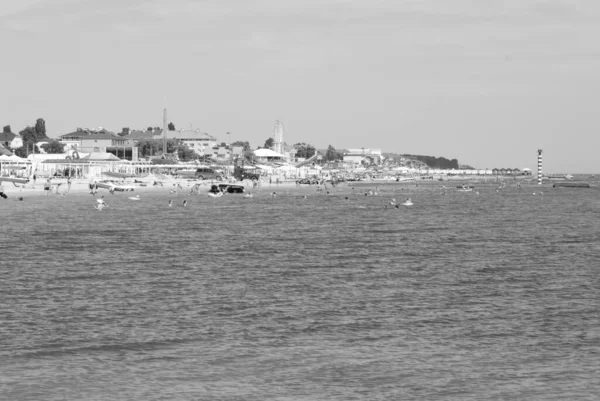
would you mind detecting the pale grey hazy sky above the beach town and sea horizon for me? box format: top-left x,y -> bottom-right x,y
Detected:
0,0 -> 600,173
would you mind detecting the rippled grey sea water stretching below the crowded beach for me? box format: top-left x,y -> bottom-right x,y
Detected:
0,184 -> 600,400
